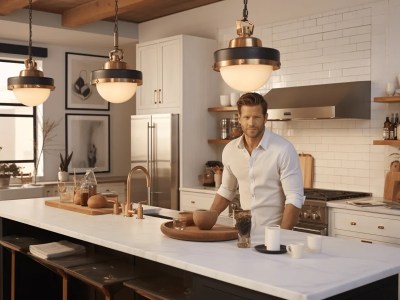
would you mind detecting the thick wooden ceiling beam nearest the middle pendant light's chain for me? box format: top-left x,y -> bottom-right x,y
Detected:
61,0 -> 146,28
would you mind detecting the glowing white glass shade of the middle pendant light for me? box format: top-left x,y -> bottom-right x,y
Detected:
96,82 -> 137,103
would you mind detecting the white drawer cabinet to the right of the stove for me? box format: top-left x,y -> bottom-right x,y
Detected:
329,208 -> 400,247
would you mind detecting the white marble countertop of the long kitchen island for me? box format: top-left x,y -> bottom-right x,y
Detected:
0,198 -> 400,300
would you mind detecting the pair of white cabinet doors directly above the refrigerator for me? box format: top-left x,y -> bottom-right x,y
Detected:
136,37 -> 182,112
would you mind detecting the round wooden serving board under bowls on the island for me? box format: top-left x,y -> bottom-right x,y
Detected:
161,221 -> 237,242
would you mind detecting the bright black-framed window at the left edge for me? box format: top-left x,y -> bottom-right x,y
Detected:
0,59 -> 37,175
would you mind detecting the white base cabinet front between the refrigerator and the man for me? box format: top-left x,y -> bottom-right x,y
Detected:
180,191 -> 229,217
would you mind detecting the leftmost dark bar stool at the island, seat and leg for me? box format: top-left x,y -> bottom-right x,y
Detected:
0,235 -> 43,300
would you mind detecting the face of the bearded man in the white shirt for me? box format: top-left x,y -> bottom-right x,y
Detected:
239,105 -> 267,138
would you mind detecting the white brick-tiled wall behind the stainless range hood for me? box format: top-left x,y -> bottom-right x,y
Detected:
139,0 -> 400,196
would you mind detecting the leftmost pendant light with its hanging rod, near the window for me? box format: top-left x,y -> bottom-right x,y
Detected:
7,0 -> 55,106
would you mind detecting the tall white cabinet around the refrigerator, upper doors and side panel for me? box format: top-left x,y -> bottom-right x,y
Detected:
136,35 -> 220,187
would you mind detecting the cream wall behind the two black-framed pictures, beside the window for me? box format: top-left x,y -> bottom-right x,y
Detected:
0,35 -> 136,181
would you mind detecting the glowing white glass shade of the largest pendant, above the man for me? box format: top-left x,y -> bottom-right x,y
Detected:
220,65 -> 273,92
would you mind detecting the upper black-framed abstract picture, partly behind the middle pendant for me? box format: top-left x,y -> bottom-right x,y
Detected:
65,52 -> 110,110
